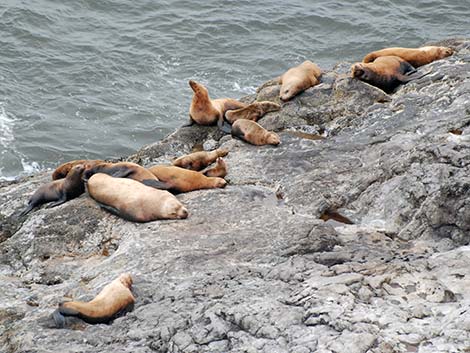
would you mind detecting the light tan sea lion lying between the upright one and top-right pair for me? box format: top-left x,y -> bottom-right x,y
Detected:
279,60 -> 322,102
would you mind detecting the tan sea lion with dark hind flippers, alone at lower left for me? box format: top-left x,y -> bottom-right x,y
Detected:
52,273 -> 135,328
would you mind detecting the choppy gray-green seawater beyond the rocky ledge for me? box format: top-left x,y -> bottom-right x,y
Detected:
0,0 -> 470,179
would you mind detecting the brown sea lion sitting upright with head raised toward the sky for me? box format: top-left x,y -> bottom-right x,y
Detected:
189,80 -> 247,125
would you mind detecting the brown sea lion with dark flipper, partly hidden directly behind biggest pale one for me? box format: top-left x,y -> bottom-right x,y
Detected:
83,162 -> 167,190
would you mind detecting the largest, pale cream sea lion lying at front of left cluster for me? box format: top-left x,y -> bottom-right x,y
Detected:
87,171 -> 188,222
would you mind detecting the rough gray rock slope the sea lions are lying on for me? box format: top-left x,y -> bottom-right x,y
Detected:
0,40 -> 470,353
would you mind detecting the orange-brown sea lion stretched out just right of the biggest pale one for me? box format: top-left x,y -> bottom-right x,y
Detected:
149,165 -> 227,192
